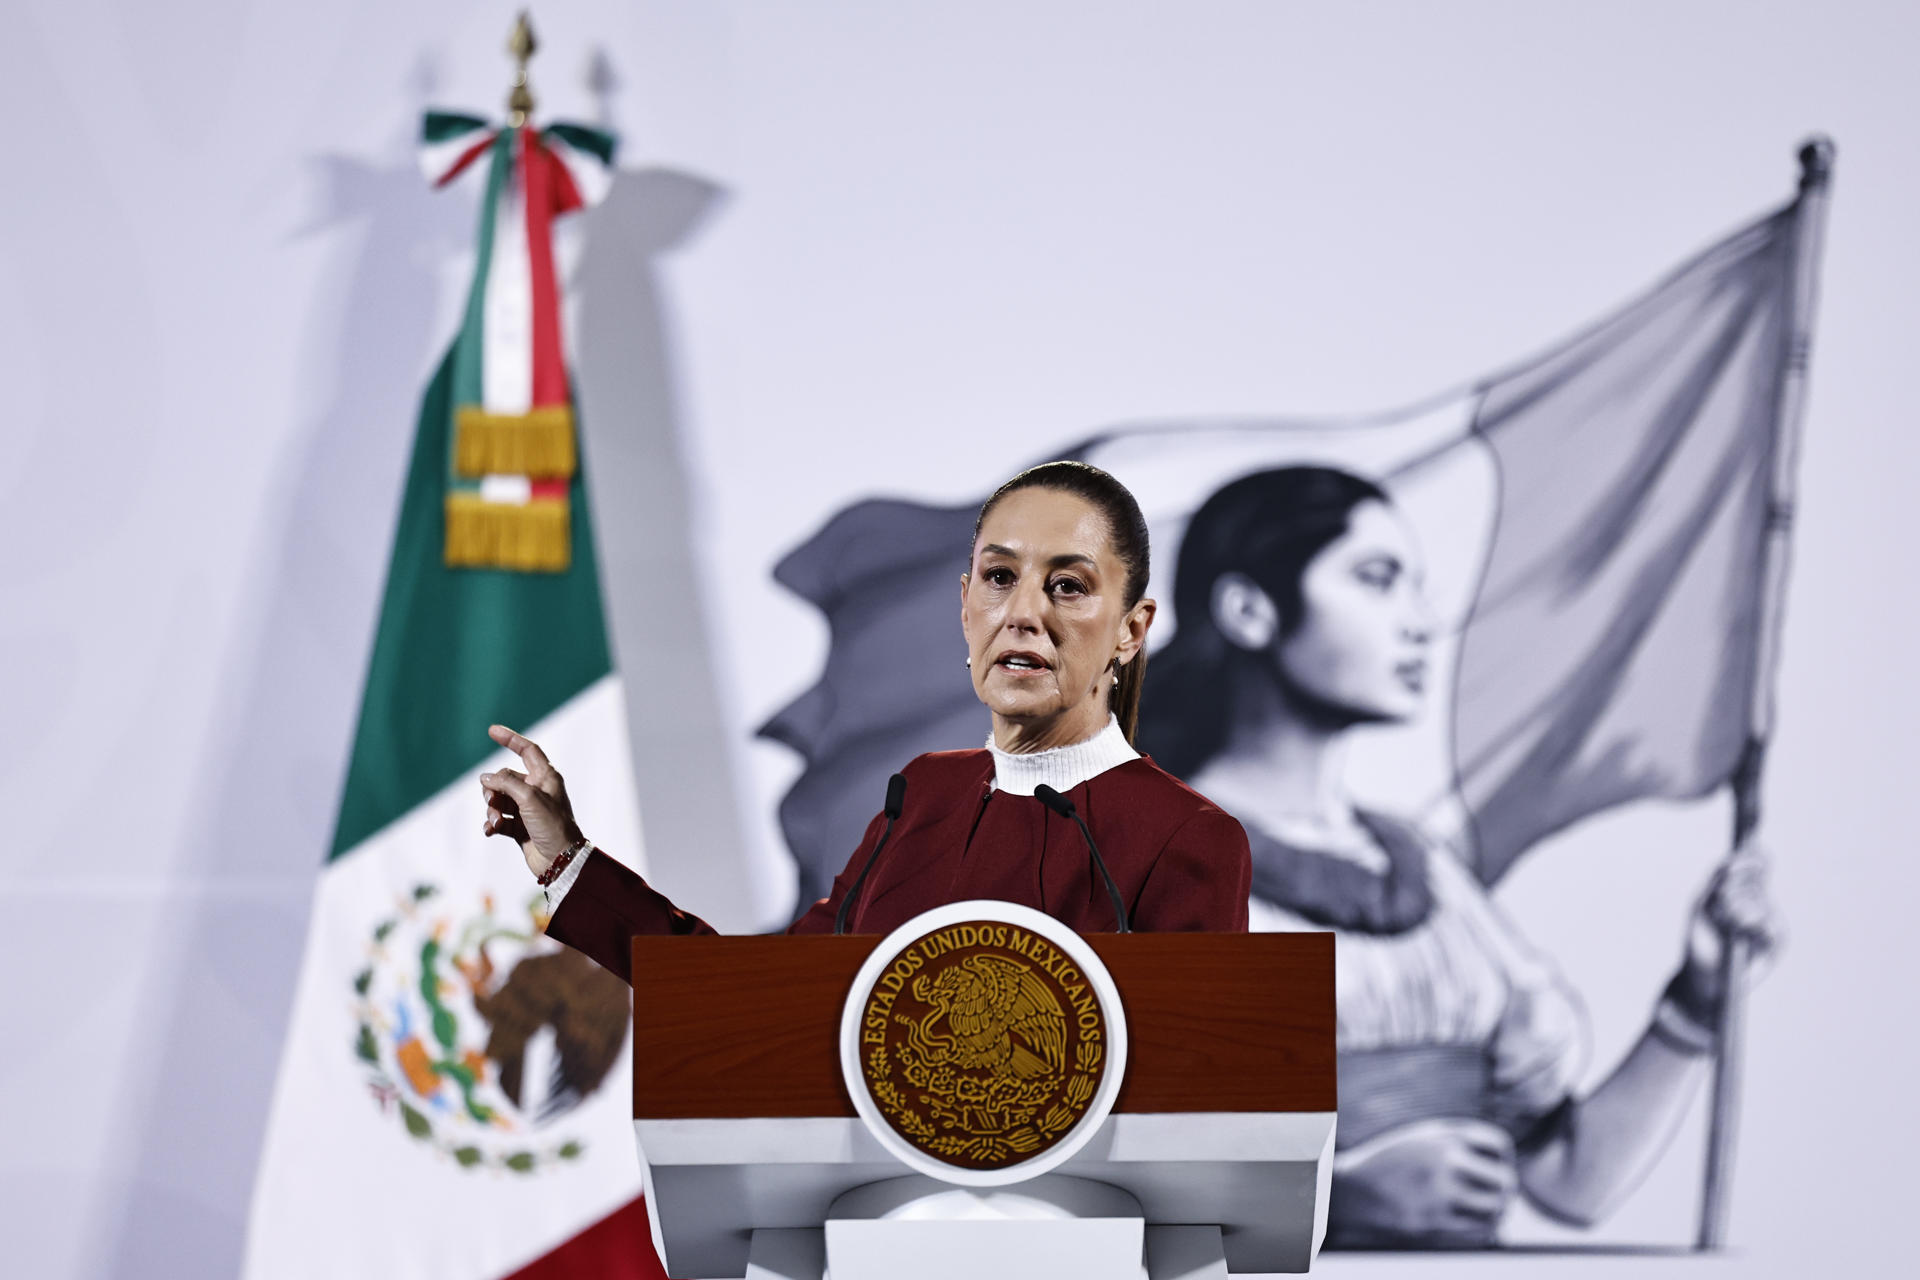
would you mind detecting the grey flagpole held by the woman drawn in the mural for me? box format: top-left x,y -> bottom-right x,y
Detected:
1695,136 -> 1834,1249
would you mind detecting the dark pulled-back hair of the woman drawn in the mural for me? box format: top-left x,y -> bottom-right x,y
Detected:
1142,466 -> 1388,777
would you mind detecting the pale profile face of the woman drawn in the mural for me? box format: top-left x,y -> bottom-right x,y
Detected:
1279,501 -> 1432,722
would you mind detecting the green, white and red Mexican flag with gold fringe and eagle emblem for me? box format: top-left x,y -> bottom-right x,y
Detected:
246,113 -> 660,1280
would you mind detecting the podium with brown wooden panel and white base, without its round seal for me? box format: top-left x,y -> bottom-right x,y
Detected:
632,933 -> 1336,1280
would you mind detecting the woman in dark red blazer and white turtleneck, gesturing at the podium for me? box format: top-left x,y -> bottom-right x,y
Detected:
480,462 -> 1252,979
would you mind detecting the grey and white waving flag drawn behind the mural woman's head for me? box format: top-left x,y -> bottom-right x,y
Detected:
762,152 -> 1803,902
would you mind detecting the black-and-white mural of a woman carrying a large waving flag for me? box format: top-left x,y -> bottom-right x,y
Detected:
741,150 -> 1832,1247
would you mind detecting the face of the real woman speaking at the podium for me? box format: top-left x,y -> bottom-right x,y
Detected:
960,487 -> 1154,748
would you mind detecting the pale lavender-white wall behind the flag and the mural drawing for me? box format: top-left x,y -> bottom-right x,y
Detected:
0,0 -> 1920,1276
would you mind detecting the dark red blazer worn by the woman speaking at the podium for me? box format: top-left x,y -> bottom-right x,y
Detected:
547,750 -> 1254,981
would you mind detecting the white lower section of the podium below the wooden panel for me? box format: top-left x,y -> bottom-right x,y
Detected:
634,1111 -> 1334,1280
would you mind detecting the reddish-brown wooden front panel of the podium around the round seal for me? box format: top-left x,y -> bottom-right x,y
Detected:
634,933 -> 1336,1119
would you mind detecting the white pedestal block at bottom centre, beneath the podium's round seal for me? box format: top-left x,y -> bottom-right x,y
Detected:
747,1174 -> 1227,1280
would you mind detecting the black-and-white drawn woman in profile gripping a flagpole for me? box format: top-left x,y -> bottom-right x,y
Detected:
1140,466 -> 1774,1247
